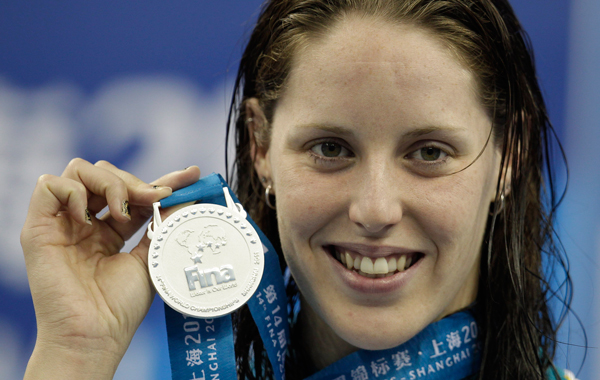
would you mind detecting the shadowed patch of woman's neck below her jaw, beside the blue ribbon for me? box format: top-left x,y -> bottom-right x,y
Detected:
298,298 -> 358,371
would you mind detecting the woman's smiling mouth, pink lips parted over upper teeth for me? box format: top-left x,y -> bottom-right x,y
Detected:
324,245 -> 423,278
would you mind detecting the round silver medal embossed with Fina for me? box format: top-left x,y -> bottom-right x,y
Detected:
148,188 -> 265,318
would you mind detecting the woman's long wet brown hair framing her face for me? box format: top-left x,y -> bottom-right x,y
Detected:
227,0 -> 571,380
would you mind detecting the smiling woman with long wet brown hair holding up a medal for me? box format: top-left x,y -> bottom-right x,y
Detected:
22,0 -> 576,379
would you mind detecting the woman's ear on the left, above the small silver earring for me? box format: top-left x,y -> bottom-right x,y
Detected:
245,98 -> 272,184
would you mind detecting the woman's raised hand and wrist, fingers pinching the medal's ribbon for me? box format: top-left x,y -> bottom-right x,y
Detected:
21,159 -> 200,379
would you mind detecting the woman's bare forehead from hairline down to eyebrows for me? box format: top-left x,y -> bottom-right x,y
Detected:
278,18 -> 485,134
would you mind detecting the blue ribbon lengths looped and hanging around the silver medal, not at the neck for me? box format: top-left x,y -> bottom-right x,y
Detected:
160,173 -> 290,380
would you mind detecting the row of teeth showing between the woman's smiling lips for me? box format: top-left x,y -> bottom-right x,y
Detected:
335,247 -> 413,278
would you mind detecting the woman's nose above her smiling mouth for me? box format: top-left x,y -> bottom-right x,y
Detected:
349,168 -> 402,234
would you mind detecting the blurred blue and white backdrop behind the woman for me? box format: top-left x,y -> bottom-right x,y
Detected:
0,0 -> 600,379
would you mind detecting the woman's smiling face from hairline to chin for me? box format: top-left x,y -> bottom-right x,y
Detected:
257,18 -> 500,349
